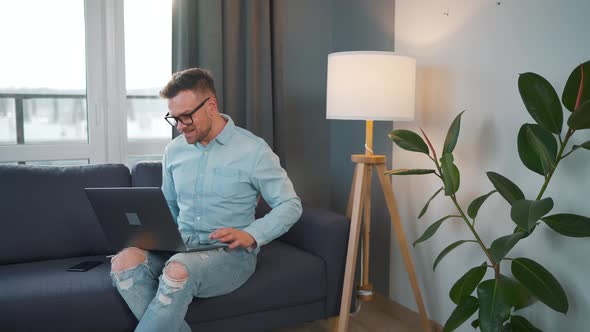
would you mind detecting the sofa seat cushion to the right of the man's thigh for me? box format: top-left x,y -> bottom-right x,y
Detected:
186,241 -> 326,324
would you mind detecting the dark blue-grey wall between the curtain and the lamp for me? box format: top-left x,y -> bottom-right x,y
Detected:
273,0 -> 394,295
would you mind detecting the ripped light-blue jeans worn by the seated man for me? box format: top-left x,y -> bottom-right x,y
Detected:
111,248 -> 257,332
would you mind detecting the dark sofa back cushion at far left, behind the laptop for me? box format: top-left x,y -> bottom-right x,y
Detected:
0,164 -> 131,264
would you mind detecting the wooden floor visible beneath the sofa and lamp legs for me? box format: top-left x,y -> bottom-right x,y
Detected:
271,296 -> 442,332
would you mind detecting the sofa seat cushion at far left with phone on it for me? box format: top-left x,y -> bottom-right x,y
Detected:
0,255 -> 137,332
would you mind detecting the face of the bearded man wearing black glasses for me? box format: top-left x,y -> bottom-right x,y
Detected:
168,90 -> 214,144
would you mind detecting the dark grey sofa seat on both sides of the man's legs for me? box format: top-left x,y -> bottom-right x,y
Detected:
0,241 -> 326,331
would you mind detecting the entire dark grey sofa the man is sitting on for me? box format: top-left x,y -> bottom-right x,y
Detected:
0,162 -> 349,331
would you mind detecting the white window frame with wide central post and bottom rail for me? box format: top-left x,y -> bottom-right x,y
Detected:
0,0 -> 172,164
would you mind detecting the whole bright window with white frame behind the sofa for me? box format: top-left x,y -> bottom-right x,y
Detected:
0,0 -> 172,164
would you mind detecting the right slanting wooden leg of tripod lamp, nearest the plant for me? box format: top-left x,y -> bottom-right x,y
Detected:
376,164 -> 431,332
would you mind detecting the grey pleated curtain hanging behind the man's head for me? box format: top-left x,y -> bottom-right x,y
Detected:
172,0 -> 275,148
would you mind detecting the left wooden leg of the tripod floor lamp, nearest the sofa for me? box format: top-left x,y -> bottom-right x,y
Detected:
338,163 -> 367,332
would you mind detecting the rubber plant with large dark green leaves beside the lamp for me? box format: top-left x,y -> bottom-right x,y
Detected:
387,61 -> 590,332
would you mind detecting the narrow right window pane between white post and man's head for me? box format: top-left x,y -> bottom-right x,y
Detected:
124,0 -> 172,166
